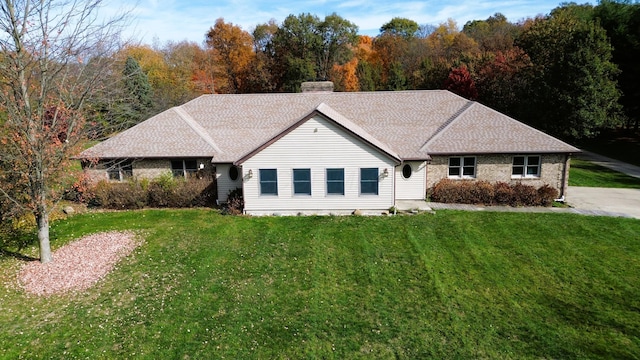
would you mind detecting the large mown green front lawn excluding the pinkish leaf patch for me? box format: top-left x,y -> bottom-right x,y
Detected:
0,210 -> 640,359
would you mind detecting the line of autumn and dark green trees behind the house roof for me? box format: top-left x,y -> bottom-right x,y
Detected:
100,0 -> 640,141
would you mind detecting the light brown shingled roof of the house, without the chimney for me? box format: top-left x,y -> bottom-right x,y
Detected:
80,90 -> 579,163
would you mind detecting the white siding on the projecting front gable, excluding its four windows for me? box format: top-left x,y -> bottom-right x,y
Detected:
243,116 -> 395,214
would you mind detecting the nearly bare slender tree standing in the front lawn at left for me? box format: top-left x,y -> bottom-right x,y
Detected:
0,0 -> 128,263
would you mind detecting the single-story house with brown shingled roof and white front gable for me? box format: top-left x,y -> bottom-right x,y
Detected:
80,83 -> 579,215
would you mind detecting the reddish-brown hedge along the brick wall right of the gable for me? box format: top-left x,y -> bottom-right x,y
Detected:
428,179 -> 558,206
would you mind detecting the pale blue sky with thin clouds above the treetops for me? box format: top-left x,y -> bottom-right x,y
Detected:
114,0 -> 576,45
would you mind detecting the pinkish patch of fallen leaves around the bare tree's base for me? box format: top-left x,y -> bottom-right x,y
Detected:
18,231 -> 140,296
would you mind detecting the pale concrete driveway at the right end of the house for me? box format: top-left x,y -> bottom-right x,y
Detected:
567,186 -> 640,219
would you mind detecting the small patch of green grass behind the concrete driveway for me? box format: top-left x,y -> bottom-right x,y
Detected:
569,159 -> 640,189
